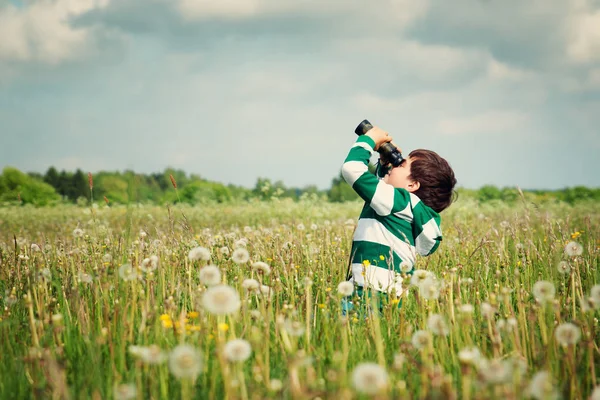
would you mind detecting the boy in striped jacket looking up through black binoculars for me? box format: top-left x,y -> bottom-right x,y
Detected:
342,127 -> 456,297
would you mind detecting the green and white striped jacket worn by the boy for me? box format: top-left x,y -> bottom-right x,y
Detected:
342,135 -> 442,295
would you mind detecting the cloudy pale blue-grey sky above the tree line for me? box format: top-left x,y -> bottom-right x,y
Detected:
0,0 -> 600,189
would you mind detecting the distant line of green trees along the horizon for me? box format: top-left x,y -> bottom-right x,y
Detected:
0,167 -> 600,206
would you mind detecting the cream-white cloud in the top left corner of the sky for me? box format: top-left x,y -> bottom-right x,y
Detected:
0,0 -> 109,64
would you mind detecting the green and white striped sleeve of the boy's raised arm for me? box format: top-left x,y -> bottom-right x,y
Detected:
342,135 -> 410,216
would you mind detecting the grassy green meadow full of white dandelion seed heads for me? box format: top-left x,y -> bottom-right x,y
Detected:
0,199 -> 600,399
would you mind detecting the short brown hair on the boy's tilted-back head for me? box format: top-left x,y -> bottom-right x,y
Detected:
409,149 -> 456,213
